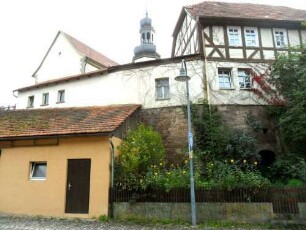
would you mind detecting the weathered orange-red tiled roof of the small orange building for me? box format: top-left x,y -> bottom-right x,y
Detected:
0,105 -> 140,140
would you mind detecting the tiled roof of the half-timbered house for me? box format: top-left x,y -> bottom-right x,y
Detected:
185,1 -> 306,21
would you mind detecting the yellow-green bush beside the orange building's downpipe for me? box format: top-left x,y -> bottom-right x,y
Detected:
115,124 -> 165,188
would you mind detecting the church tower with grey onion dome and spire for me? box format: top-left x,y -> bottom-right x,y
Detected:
133,12 -> 160,62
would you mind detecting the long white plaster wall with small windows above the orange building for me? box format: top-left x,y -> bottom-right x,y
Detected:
17,61 -> 203,109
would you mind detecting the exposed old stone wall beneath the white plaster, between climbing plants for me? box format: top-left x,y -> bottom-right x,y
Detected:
140,105 -> 276,162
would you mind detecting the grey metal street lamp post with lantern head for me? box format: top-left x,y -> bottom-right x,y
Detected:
175,59 -> 196,226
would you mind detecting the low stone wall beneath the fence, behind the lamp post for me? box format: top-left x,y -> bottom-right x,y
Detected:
113,202 -> 306,224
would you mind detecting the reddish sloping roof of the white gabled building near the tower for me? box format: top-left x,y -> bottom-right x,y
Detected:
61,31 -> 118,67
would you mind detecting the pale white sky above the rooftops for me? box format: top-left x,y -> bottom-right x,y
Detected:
0,0 -> 306,106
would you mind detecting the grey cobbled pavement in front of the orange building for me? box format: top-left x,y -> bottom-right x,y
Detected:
0,214 -> 194,230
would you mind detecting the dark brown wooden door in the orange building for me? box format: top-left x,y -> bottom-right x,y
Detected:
65,159 -> 91,213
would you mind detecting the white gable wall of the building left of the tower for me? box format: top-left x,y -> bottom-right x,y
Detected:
36,34 -> 86,82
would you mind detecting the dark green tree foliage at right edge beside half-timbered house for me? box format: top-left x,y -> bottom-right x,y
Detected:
270,49 -> 306,146
